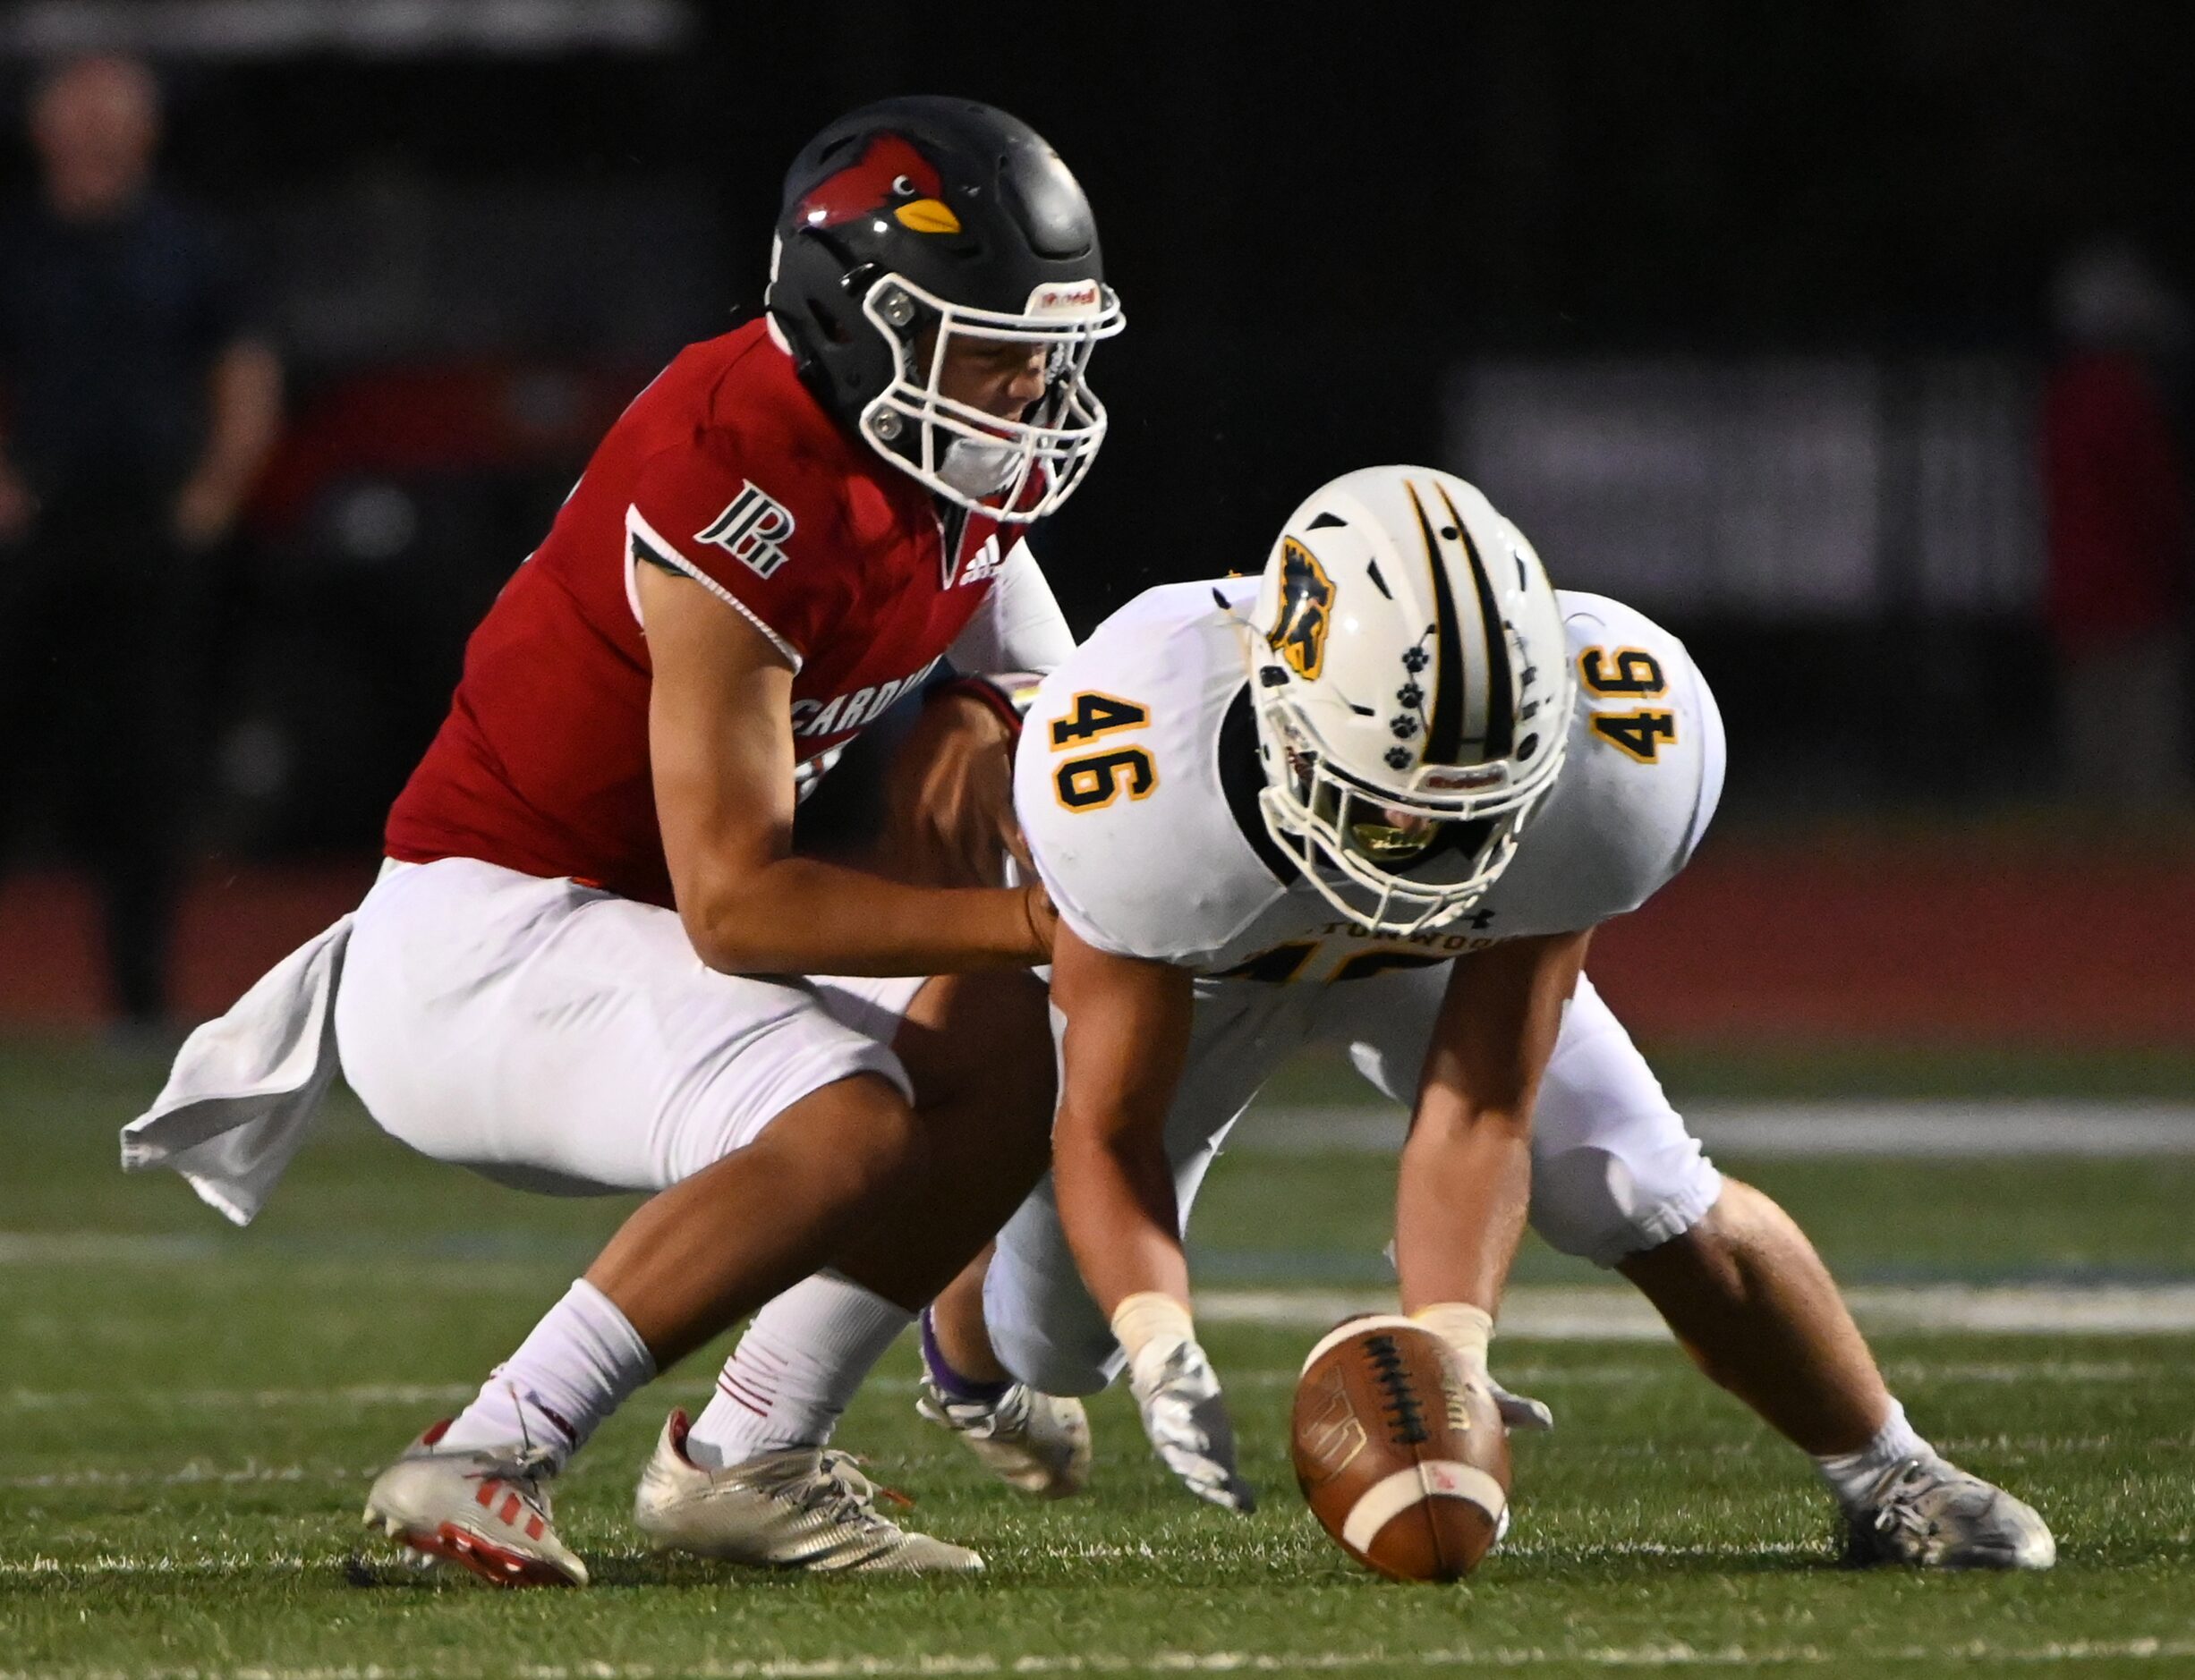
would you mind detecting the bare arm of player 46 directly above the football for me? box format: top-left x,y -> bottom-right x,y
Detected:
1394,932 -> 1591,1423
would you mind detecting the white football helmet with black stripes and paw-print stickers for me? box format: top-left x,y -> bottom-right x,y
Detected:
1246,467 -> 1576,934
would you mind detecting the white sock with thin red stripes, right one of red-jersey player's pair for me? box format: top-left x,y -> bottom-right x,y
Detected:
687,1272 -> 915,1470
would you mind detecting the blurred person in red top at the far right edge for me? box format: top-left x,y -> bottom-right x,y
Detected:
2044,242 -> 2195,810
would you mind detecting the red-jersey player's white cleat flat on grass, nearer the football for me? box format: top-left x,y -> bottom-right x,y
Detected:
632,1413 -> 983,1574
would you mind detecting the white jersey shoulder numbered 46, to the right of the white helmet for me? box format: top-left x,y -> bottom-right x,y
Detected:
1482,590 -> 1723,938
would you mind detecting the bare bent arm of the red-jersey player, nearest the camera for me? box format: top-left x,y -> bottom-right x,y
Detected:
634,566 -> 1051,974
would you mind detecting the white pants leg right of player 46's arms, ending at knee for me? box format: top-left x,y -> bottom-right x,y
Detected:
1532,976 -> 1723,1266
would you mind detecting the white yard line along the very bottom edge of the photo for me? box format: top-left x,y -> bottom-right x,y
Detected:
0,1638 -> 2195,1680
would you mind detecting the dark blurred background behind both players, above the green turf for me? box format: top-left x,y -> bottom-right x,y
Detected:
0,0 -> 2195,1048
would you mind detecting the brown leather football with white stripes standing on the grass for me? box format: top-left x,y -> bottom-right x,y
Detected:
1293,1316 -> 1510,1582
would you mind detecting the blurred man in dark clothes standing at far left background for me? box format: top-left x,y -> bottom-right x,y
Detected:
0,57 -> 281,1026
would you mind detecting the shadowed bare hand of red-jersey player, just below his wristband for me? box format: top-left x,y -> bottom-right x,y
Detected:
881,693 -> 1021,886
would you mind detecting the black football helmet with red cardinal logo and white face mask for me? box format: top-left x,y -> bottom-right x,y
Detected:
769,97 -> 1121,524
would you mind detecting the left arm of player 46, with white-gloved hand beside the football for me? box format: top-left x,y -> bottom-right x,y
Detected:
1051,926 -> 1258,1511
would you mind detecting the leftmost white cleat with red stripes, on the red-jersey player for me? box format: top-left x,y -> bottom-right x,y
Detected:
364,1419 -> 586,1586
